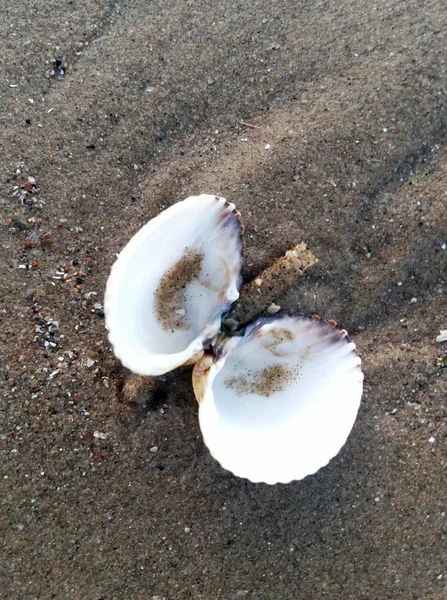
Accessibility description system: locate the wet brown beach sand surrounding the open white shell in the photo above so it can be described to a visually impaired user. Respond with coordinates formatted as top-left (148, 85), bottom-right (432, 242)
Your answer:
top-left (0, 0), bottom-right (447, 600)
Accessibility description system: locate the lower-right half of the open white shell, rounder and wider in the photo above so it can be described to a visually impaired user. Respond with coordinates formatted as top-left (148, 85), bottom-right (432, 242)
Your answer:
top-left (198, 316), bottom-right (363, 484)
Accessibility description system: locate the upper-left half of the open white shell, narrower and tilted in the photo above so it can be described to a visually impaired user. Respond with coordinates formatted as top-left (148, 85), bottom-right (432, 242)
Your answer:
top-left (104, 194), bottom-right (242, 375)
